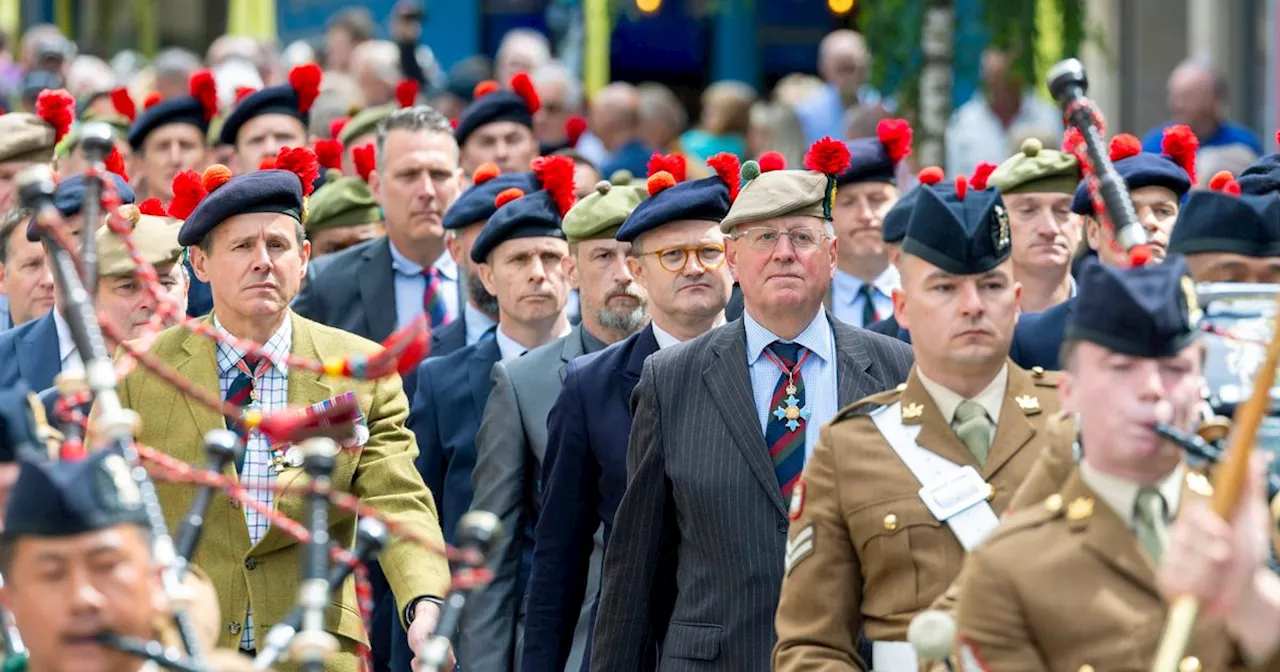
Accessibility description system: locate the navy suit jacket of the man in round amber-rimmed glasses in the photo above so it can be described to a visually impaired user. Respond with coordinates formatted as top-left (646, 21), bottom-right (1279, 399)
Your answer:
top-left (521, 326), bottom-right (658, 672)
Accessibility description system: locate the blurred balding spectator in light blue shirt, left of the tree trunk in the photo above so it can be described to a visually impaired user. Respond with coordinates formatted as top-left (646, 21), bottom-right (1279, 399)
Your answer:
top-left (796, 29), bottom-right (881, 143)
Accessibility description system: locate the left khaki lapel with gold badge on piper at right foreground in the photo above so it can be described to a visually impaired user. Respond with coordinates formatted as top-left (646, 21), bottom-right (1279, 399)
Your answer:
top-left (1062, 468), bottom-right (1160, 596)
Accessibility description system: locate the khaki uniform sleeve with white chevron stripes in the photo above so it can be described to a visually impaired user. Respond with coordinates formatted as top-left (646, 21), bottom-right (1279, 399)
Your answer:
top-left (773, 424), bottom-right (867, 672)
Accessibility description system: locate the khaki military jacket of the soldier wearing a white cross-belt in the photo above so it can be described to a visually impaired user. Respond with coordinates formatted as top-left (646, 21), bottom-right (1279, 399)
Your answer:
top-left (773, 362), bottom-right (1070, 671)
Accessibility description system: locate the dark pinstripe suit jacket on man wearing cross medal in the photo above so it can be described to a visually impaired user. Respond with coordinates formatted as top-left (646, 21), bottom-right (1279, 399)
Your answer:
top-left (591, 314), bottom-right (913, 672)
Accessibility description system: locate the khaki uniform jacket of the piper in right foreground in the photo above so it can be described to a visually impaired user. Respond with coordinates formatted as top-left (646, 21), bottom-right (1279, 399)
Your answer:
top-left (956, 467), bottom-right (1239, 672)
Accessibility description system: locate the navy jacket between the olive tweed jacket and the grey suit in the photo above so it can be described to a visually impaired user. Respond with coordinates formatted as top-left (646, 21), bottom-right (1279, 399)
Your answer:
top-left (408, 338), bottom-right (502, 544)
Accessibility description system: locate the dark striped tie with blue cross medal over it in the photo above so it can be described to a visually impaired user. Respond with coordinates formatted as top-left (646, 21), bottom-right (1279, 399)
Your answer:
top-left (763, 340), bottom-right (809, 500)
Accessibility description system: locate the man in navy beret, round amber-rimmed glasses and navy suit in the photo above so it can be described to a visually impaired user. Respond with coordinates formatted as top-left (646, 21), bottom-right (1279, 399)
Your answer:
top-left (521, 156), bottom-right (739, 672)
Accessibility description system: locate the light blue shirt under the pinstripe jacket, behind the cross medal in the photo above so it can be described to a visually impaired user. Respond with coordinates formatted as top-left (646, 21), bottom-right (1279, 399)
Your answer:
top-left (742, 311), bottom-right (840, 462)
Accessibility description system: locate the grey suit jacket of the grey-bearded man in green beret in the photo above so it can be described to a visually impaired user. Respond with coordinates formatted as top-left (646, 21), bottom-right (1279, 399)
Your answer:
top-left (468, 325), bottom-right (593, 672)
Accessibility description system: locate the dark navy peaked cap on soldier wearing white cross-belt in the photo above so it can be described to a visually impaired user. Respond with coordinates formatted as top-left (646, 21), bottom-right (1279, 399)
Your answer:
top-left (902, 183), bottom-right (1011, 275)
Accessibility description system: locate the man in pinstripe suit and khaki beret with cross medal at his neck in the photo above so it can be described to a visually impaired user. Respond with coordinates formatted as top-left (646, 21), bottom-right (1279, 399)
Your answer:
top-left (591, 138), bottom-right (911, 672)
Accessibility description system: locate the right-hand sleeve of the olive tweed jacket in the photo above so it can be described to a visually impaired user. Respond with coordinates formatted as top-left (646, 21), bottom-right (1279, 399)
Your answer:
top-left (352, 366), bottom-right (451, 618)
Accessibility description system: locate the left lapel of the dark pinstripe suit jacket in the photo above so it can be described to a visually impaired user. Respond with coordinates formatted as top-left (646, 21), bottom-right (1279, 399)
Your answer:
top-left (703, 319), bottom-right (787, 516)
